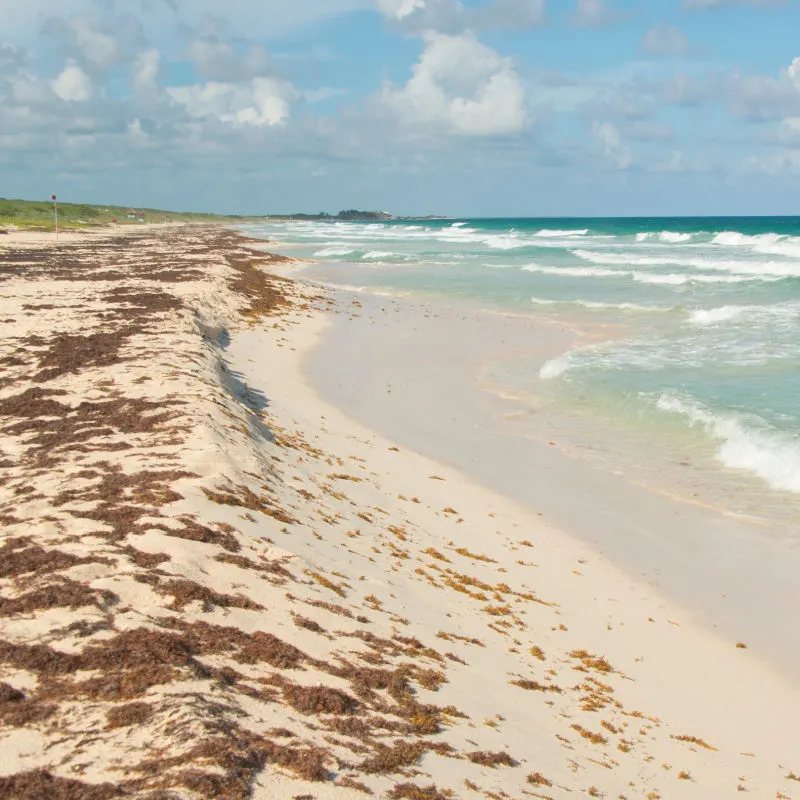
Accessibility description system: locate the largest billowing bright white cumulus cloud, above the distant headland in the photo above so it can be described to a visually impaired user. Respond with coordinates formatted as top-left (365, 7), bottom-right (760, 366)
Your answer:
top-left (377, 33), bottom-right (526, 136)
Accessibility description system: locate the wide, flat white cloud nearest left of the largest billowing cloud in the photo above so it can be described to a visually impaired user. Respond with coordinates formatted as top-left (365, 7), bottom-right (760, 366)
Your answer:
top-left (167, 78), bottom-right (297, 127)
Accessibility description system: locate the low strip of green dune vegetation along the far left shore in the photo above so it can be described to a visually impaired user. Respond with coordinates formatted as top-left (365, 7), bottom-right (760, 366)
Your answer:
top-left (0, 198), bottom-right (264, 230)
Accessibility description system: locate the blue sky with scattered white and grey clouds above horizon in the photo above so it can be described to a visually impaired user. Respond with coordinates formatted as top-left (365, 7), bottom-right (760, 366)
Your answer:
top-left (0, 0), bottom-right (800, 216)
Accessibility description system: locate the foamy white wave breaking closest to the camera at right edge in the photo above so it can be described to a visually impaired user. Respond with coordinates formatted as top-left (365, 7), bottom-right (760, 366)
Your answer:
top-left (652, 394), bottom-right (800, 492)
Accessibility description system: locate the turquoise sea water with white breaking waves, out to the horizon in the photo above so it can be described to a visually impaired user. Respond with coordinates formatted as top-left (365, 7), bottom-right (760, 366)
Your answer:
top-left (248, 217), bottom-right (800, 506)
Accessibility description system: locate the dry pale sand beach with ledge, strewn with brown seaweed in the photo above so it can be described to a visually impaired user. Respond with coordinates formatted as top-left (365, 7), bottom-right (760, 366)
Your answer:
top-left (0, 227), bottom-right (800, 800)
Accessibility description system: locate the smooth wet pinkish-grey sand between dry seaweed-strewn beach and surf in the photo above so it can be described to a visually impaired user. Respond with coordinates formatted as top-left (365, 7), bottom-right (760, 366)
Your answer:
top-left (308, 276), bottom-right (800, 675)
